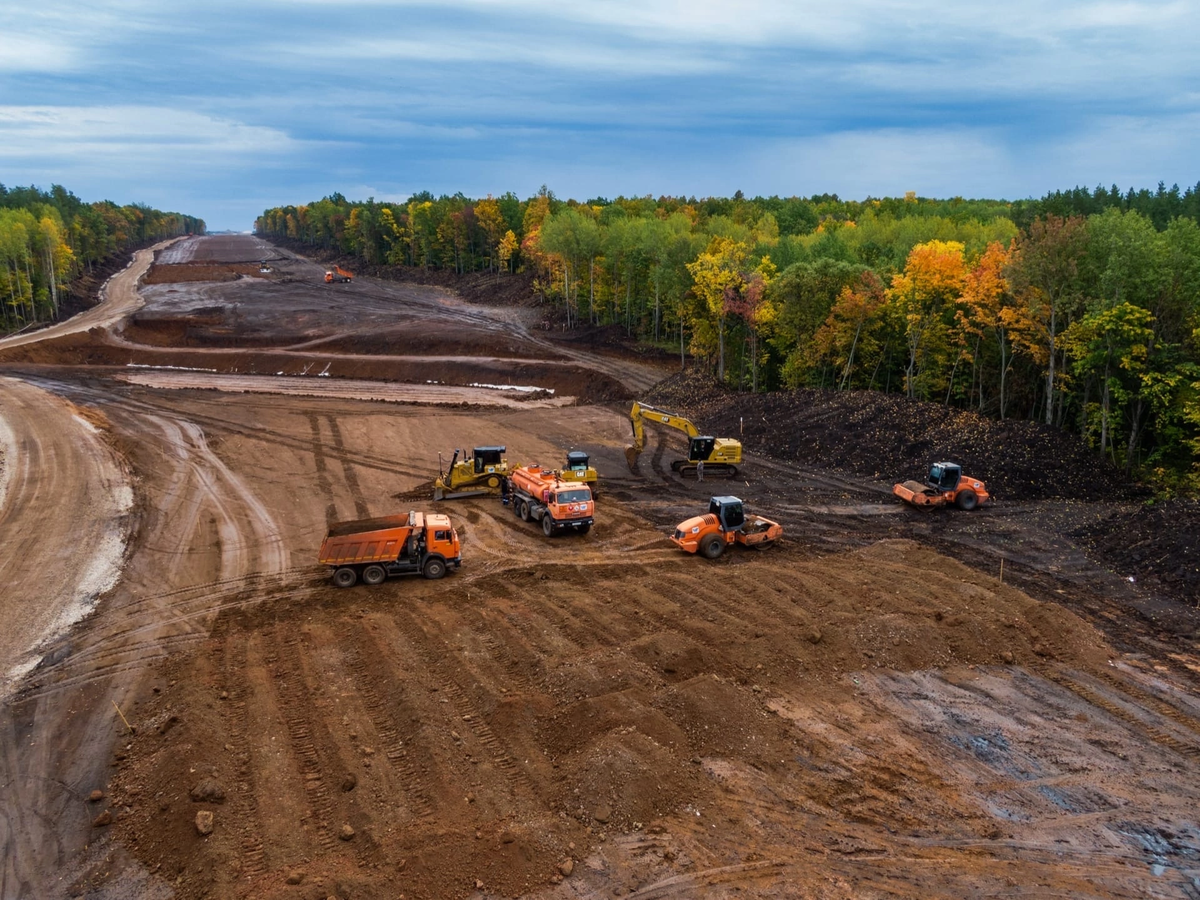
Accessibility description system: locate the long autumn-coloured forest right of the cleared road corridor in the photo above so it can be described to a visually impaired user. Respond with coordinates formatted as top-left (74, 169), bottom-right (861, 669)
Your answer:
top-left (257, 184), bottom-right (1200, 488)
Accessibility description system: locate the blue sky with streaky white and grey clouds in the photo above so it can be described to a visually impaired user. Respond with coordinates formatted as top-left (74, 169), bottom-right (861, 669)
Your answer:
top-left (0, 0), bottom-right (1200, 229)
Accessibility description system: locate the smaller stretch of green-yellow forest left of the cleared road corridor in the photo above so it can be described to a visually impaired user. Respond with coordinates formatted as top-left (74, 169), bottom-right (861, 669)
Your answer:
top-left (0, 184), bottom-right (204, 334)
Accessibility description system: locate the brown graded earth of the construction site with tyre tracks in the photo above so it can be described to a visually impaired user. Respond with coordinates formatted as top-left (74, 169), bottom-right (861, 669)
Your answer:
top-left (0, 235), bottom-right (1200, 900)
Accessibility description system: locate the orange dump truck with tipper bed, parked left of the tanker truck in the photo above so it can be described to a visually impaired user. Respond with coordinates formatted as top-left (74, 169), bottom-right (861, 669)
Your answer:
top-left (318, 510), bottom-right (462, 588)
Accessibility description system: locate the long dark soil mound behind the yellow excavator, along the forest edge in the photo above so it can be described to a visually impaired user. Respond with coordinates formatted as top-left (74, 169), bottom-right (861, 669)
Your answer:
top-left (647, 371), bottom-right (1138, 500)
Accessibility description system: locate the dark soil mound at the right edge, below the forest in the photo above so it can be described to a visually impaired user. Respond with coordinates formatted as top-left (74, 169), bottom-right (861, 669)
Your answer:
top-left (1074, 500), bottom-right (1200, 606)
